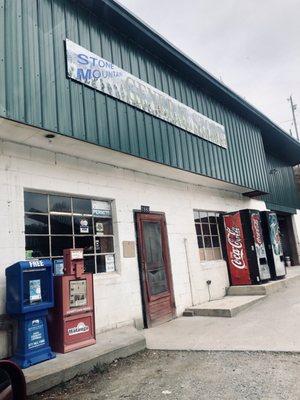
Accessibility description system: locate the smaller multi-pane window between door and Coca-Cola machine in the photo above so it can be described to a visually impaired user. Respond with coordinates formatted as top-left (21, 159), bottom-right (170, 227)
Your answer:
top-left (194, 210), bottom-right (223, 261)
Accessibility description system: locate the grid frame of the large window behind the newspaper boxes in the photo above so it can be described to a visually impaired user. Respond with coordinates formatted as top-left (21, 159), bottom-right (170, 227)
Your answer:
top-left (23, 189), bottom-right (117, 275)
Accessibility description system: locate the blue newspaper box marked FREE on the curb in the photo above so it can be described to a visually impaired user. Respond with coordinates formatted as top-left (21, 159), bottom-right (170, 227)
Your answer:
top-left (5, 260), bottom-right (55, 368)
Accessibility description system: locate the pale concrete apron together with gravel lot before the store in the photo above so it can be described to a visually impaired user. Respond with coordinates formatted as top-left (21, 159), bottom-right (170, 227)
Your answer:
top-left (29, 270), bottom-right (300, 400)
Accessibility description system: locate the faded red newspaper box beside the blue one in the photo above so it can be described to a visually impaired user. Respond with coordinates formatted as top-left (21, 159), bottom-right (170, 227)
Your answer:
top-left (48, 249), bottom-right (96, 353)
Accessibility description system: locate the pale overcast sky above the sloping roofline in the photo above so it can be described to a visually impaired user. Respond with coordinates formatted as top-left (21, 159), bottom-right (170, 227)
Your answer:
top-left (118, 0), bottom-right (300, 137)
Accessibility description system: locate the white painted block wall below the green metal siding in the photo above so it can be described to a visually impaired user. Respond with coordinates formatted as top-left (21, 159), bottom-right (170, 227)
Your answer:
top-left (0, 137), bottom-right (268, 353)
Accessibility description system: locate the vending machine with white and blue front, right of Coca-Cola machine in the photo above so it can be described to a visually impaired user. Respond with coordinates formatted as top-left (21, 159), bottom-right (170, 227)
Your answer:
top-left (260, 211), bottom-right (286, 279)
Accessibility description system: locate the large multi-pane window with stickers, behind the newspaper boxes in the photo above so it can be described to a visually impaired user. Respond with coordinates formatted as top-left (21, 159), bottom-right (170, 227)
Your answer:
top-left (24, 191), bottom-right (115, 273)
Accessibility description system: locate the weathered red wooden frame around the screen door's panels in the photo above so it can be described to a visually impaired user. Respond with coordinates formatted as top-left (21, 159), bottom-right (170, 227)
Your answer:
top-left (133, 210), bottom-right (176, 328)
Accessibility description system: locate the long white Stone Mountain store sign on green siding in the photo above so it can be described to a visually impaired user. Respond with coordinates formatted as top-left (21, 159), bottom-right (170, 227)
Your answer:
top-left (66, 39), bottom-right (227, 148)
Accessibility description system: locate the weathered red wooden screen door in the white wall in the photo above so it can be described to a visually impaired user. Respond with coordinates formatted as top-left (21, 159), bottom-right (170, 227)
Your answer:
top-left (136, 213), bottom-right (175, 327)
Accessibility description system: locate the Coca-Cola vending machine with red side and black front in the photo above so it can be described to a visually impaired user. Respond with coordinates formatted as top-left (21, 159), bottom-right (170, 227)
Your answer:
top-left (222, 210), bottom-right (271, 286)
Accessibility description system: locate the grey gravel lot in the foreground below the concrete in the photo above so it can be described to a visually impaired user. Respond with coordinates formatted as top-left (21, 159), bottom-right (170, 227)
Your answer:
top-left (30, 350), bottom-right (300, 400)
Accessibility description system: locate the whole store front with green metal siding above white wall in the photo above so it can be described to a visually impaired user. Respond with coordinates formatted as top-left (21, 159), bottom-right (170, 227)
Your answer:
top-left (0, 0), bottom-right (300, 355)
